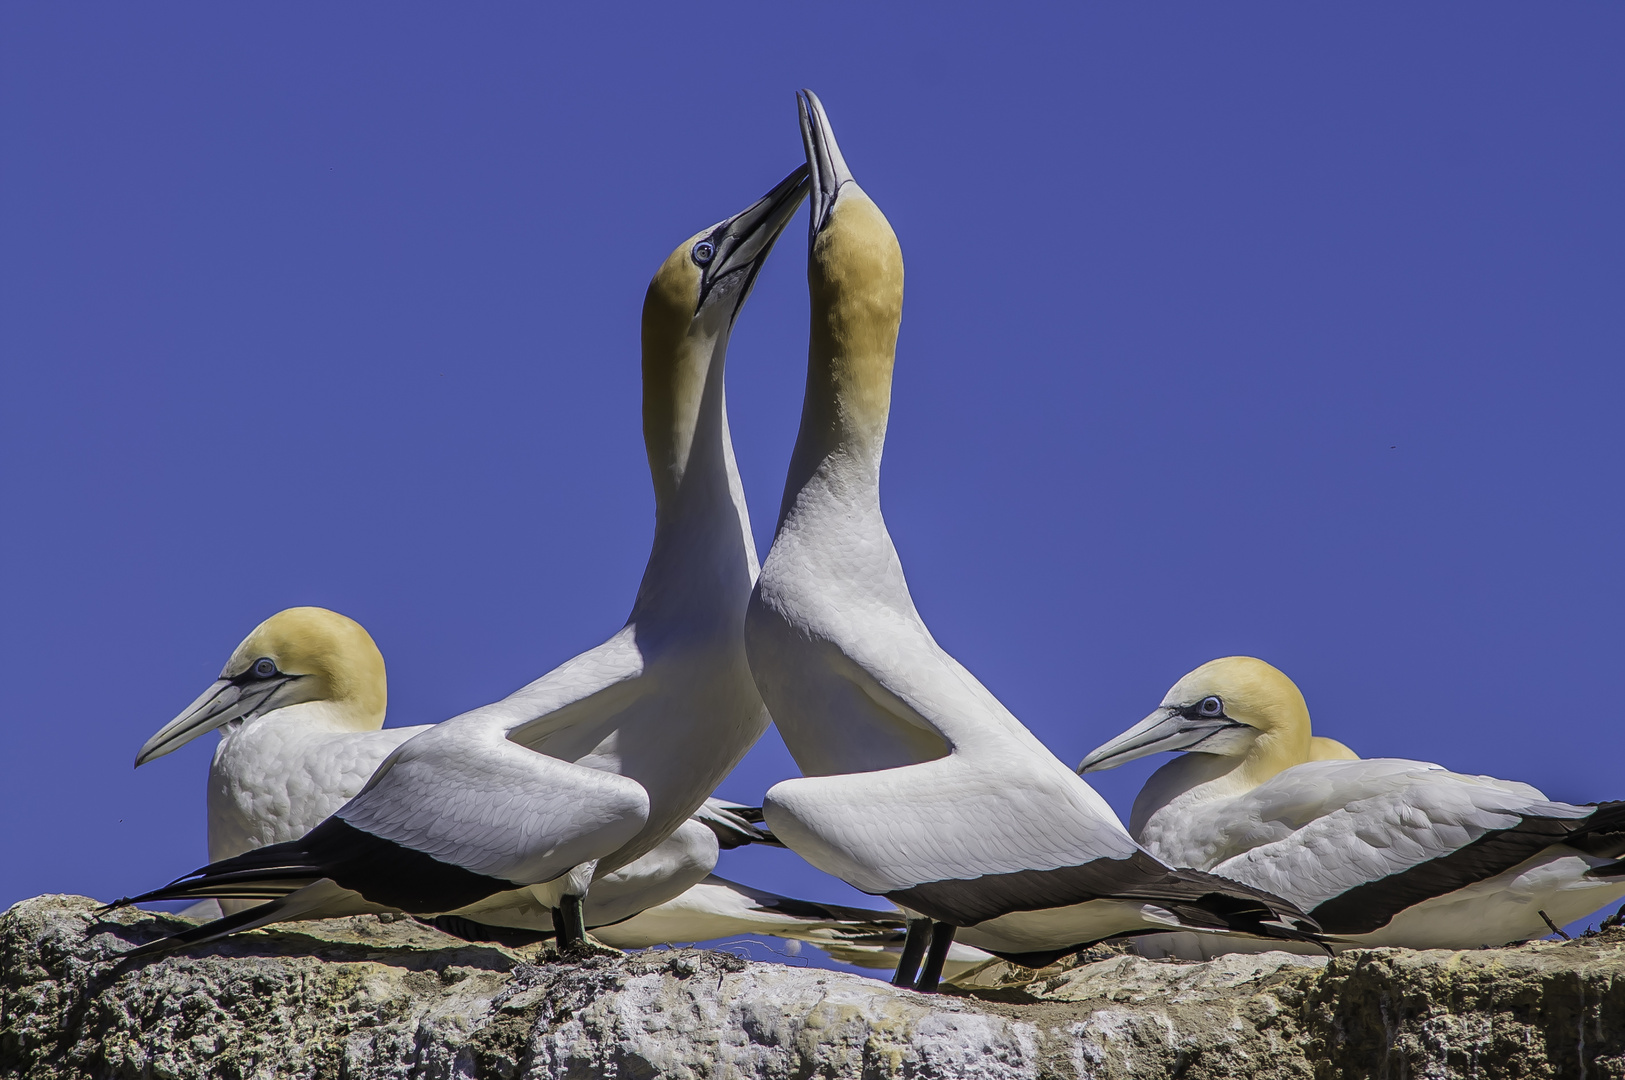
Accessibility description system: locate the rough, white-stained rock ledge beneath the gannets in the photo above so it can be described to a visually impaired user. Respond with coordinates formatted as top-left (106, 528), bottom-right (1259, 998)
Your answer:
top-left (0, 896), bottom-right (1625, 1080)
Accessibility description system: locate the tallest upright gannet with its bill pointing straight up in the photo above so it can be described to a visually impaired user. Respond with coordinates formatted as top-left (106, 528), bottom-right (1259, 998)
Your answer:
top-left (746, 91), bottom-right (1308, 991)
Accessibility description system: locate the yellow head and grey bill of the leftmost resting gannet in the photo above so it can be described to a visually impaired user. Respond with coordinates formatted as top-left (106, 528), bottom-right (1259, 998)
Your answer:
top-left (135, 607), bottom-right (388, 765)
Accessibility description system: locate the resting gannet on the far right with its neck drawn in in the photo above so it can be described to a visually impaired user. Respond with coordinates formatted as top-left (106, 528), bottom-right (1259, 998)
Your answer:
top-left (1079, 656), bottom-right (1625, 958)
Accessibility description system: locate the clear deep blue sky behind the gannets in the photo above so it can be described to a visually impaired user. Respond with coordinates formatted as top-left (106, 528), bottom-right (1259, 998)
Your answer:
top-left (0, 3), bottom-right (1625, 961)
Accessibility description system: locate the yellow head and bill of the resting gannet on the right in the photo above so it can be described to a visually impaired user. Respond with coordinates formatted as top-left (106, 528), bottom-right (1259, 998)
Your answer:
top-left (1077, 656), bottom-right (1354, 783)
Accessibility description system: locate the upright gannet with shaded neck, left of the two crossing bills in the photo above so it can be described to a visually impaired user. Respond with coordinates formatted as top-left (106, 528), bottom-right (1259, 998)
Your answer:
top-left (120, 166), bottom-right (808, 952)
